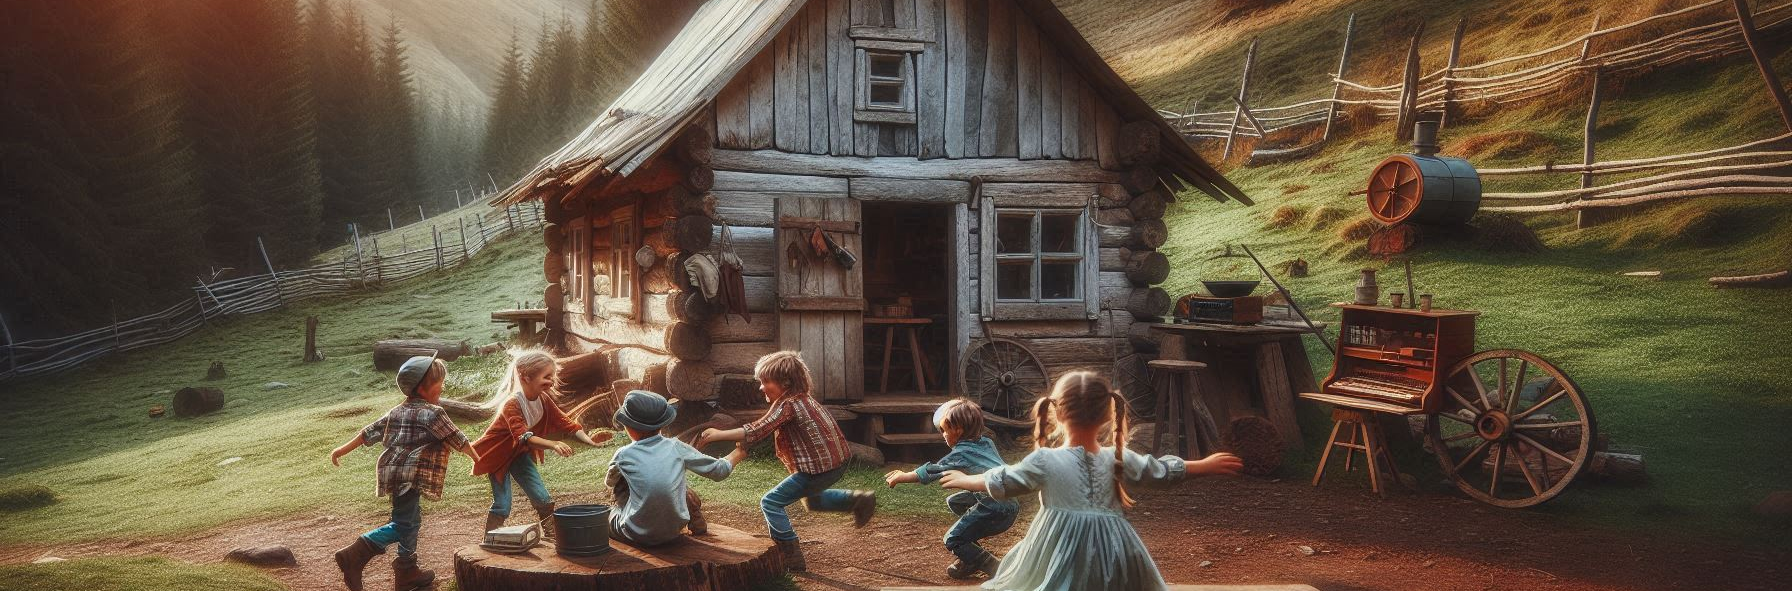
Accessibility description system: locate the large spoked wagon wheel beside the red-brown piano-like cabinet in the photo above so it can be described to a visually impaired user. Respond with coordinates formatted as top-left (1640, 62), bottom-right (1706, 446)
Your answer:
top-left (1425, 349), bottom-right (1595, 509)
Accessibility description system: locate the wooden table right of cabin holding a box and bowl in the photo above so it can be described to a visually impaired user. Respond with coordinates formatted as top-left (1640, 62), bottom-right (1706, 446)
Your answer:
top-left (1150, 322), bottom-right (1324, 450)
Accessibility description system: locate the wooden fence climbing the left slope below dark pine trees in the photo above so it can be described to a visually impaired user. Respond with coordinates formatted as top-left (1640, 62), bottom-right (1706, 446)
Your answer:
top-left (0, 202), bottom-right (543, 380)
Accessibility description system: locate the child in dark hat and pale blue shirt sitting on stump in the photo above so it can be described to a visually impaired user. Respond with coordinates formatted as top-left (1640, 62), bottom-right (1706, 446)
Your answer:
top-left (604, 390), bottom-right (747, 546)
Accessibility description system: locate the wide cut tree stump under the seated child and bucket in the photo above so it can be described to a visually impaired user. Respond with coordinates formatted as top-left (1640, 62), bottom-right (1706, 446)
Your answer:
top-left (453, 523), bottom-right (783, 591)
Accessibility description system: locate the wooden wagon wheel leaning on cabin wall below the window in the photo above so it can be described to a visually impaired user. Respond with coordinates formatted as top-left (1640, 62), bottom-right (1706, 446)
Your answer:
top-left (959, 338), bottom-right (1047, 421)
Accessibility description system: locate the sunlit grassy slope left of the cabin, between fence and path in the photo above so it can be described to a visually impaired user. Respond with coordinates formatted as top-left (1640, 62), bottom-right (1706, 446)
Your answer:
top-left (0, 238), bottom-right (939, 544)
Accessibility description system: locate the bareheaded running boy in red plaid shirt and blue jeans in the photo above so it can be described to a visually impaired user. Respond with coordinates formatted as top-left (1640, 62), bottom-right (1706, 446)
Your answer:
top-left (697, 351), bottom-right (878, 571)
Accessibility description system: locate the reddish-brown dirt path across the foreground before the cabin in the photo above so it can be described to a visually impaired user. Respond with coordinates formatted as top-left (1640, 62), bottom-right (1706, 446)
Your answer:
top-left (0, 480), bottom-right (1792, 591)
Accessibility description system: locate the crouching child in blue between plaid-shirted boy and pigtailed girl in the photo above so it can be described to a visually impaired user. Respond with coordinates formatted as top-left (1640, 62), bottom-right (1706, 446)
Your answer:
top-left (883, 398), bottom-right (1020, 578)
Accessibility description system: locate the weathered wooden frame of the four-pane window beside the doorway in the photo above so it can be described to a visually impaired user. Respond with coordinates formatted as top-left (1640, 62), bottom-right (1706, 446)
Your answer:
top-left (978, 202), bottom-right (1100, 321)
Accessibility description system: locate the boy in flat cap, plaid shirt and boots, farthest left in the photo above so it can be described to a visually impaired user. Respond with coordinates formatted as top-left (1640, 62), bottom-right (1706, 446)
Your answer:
top-left (330, 356), bottom-right (478, 591)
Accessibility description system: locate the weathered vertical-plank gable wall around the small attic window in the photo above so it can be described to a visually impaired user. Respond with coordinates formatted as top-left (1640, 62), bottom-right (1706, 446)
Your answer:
top-left (715, 0), bottom-right (1118, 161)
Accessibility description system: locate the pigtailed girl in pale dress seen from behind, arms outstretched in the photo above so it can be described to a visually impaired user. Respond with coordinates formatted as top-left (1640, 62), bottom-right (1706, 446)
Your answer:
top-left (941, 371), bottom-right (1244, 591)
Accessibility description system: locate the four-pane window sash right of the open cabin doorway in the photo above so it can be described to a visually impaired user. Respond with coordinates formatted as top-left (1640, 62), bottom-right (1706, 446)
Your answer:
top-left (993, 210), bottom-right (1084, 303)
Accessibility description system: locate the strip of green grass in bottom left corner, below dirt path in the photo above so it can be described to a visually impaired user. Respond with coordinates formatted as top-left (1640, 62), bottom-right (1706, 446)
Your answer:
top-left (0, 559), bottom-right (285, 591)
